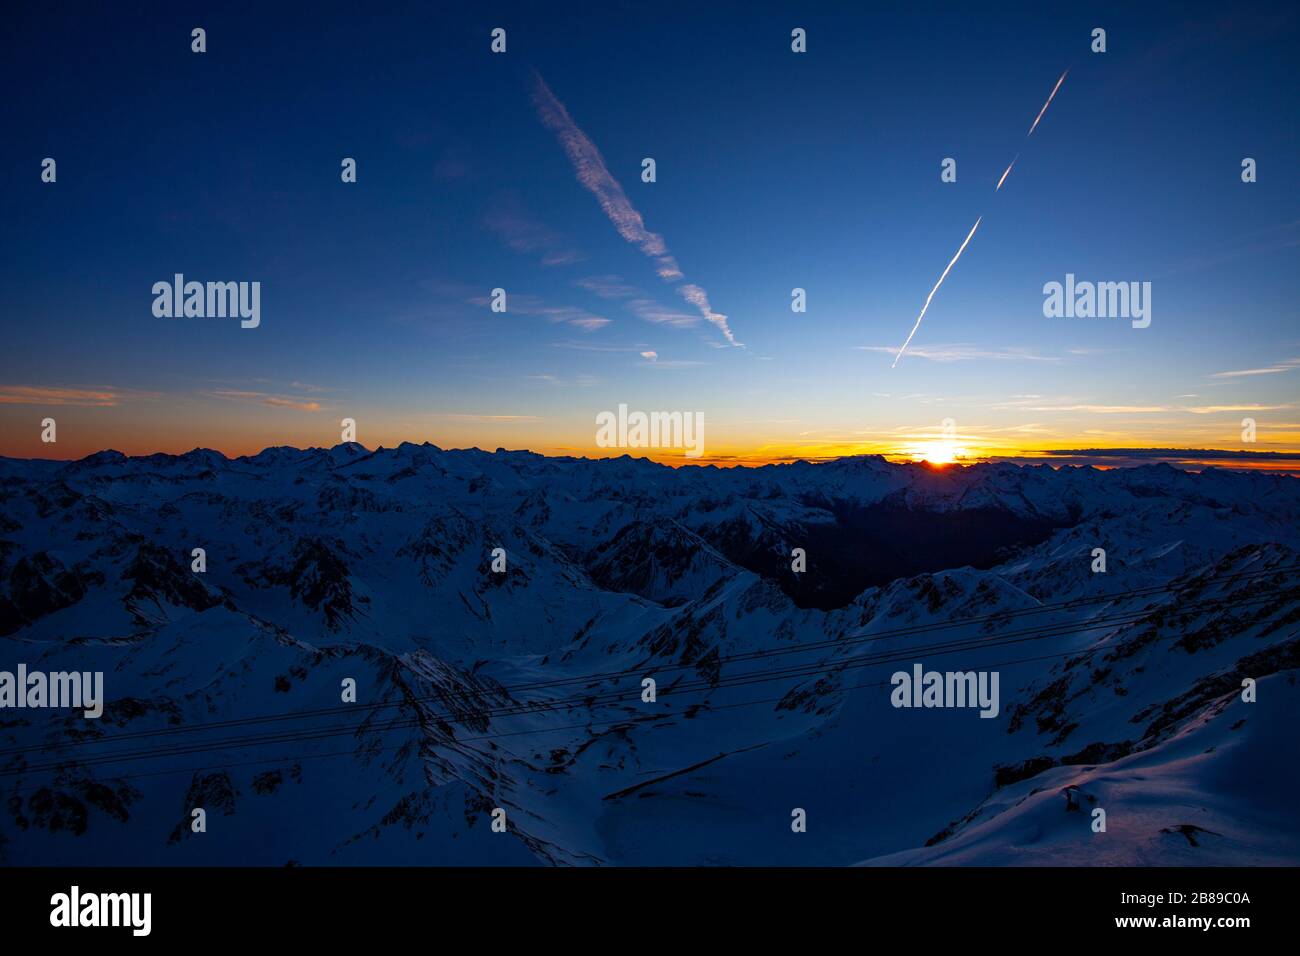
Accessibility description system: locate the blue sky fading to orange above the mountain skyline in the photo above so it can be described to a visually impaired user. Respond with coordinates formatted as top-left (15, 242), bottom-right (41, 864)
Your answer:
top-left (0, 3), bottom-right (1300, 464)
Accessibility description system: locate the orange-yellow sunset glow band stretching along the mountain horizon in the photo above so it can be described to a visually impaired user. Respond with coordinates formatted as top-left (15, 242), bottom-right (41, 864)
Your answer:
top-left (0, 403), bottom-right (1300, 473)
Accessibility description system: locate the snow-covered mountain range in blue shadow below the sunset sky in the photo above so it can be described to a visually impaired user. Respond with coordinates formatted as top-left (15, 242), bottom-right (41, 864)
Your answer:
top-left (0, 444), bottom-right (1300, 865)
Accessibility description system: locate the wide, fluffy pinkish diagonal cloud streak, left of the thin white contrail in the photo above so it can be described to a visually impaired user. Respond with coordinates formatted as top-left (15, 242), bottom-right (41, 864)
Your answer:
top-left (533, 74), bottom-right (740, 346)
